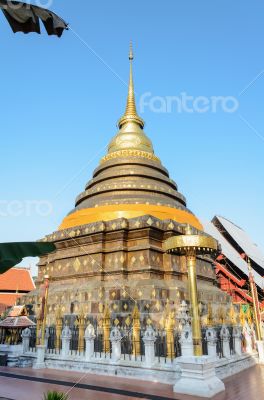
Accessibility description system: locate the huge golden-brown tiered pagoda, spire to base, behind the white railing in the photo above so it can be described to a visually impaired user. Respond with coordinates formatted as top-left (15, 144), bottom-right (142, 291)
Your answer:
top-left (23, 46), bottom-right (231, 323)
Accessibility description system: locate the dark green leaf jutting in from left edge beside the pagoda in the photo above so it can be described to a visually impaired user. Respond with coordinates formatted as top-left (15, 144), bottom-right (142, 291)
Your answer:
top-left (0, 242), bottom-right (56, 274)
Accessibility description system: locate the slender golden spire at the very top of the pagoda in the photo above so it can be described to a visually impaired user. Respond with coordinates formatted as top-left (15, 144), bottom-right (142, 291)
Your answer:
top-left (118, 42), bottom-right (144, 128)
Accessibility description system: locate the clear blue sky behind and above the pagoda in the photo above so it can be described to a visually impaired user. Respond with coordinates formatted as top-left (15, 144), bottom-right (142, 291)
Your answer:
top-left (0, 0), bottom-right (264, 274)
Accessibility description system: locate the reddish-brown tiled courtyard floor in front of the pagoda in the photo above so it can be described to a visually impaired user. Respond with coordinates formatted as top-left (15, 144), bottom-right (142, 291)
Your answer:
top-left (0, 365), bottom-right (264, 400)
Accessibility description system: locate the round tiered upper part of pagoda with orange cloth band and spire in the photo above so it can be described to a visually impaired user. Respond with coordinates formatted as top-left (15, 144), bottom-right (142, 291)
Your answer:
top-left (59, 46), bottom-right (202, 229)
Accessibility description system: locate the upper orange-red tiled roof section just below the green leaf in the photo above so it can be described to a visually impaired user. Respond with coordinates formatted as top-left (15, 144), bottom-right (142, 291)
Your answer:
top-left (0, 268), bottom-right (35, 292)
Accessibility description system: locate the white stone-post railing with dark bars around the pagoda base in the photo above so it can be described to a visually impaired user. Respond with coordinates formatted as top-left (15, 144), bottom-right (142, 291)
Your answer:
top-left (22, 323), bottom-right (253, 365)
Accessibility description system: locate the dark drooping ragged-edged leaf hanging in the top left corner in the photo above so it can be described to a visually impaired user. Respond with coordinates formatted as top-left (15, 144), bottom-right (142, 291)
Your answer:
top-left (0, 0), bottom-right (68, 37)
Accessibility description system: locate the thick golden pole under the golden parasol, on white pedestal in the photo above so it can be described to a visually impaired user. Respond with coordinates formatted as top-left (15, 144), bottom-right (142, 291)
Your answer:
top-left (186, 252), bottom-right (203, 356)
